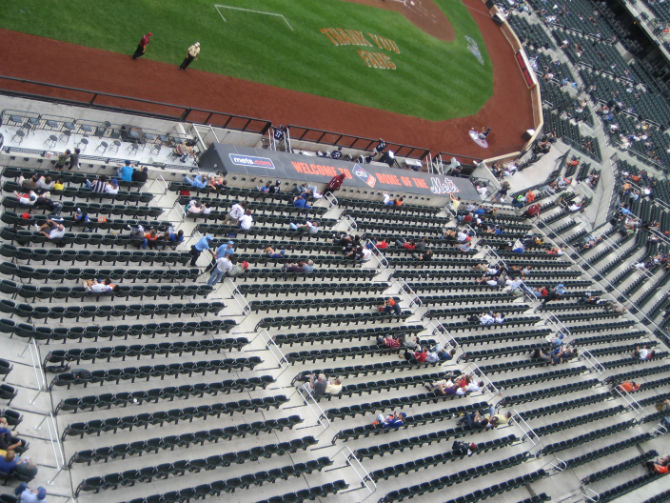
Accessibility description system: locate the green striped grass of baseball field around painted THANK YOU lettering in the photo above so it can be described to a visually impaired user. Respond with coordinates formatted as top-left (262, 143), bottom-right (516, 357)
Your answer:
top-left (0, 0), bottom-right (493, 121)
